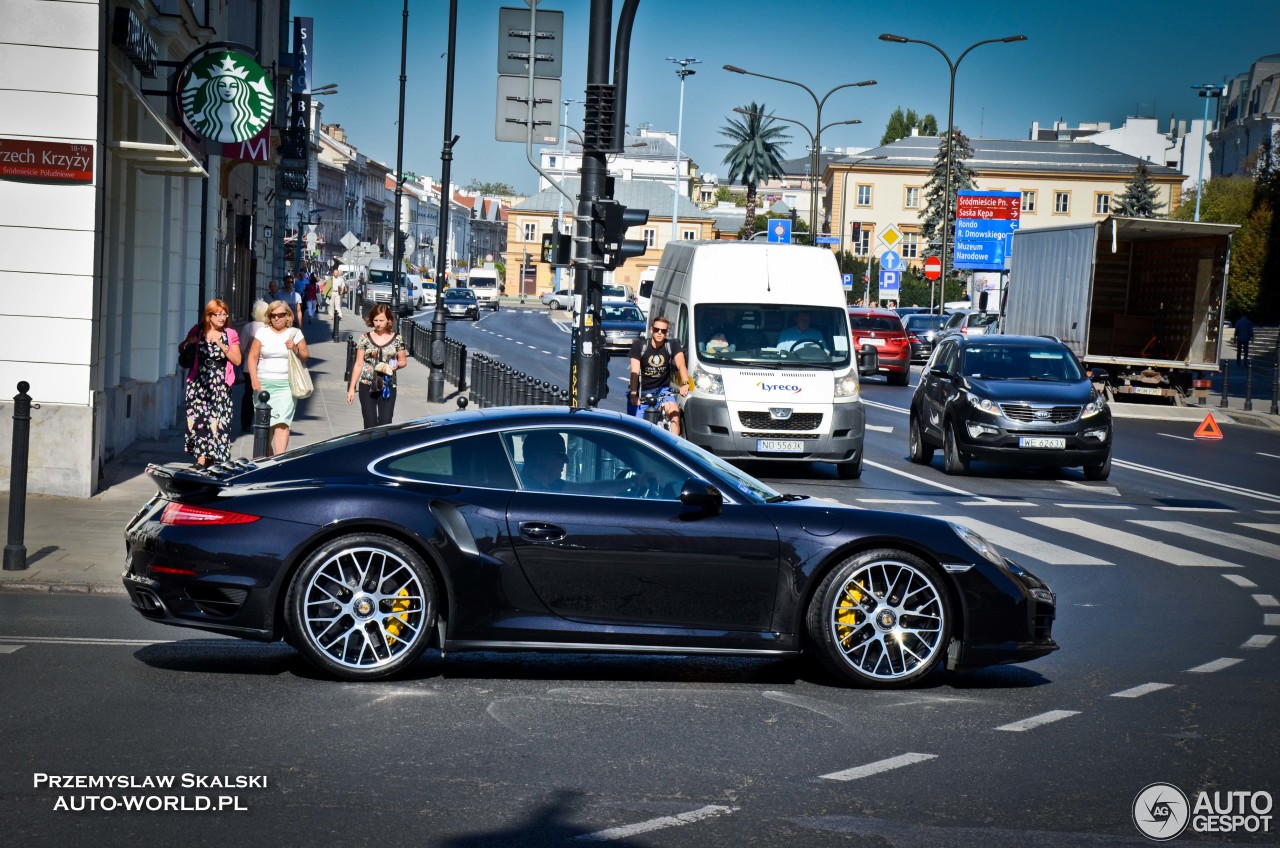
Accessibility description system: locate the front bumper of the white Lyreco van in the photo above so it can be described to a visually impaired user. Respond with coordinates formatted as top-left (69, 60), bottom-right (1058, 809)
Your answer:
top-left (681, 395), bottom-right (867, 462)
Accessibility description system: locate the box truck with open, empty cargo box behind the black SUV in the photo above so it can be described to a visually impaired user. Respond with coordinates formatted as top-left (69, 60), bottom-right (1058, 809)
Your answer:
top-left (1000, 216), bottom-right (1236, 404)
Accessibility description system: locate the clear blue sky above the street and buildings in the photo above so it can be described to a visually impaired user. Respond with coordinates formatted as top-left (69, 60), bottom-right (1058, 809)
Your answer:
top-left (291, 0), bottom-right (1280, 192)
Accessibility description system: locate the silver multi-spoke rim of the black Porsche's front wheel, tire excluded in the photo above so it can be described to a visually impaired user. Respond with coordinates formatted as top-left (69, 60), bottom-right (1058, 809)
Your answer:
top-left (829, 559), bottom-right (948, 681)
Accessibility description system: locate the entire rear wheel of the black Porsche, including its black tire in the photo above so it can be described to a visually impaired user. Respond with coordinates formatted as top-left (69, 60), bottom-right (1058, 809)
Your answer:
top-left (285, 533), bottom-right (439, 680)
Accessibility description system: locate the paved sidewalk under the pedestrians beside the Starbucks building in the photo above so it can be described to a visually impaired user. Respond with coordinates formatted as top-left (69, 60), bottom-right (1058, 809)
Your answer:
top-left (0, 310), bottom-right (457, 594)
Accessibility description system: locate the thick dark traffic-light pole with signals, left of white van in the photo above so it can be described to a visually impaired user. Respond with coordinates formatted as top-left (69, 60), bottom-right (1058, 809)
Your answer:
top-left (570, 0), bottom-right (649, 409)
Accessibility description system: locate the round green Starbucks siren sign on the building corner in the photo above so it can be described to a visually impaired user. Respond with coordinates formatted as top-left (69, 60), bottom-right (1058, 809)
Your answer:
top-left (182, 50), bottom-right (275, 143)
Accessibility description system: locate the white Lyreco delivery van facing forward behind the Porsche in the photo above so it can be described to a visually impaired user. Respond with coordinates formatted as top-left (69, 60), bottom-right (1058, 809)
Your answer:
top-left (649, 241), bottom-right (865, 479)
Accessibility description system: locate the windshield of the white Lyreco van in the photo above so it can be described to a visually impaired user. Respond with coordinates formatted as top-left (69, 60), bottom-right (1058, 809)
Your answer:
top-left (694, 304), bottom-right (850, 368)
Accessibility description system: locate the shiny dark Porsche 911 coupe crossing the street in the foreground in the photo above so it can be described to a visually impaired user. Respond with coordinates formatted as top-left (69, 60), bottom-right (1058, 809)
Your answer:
top-left (124, 407), bottom-right (1057, 688)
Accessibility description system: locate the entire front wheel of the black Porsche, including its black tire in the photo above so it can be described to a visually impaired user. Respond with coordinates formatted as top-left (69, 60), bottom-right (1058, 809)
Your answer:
top-left (805, 548), bottom-right (951, 689)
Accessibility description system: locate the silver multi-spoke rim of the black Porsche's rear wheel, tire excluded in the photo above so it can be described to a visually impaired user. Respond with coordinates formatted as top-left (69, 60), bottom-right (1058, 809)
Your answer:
top-left (300, 547), bottom-right (431, 670)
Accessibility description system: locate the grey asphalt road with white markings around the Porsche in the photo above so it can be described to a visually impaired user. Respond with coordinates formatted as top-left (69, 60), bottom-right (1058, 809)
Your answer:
top-left (0, 310), bottom-right (1280, 848)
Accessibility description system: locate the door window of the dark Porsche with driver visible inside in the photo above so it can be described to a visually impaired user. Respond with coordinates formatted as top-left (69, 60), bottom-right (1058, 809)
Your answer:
top-left (503, 427), bottom-right (689, 501)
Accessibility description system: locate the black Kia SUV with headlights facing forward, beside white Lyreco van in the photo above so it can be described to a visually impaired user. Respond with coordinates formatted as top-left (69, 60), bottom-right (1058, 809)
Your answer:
top-left (908, 333), bottom-right (1111, 480)
